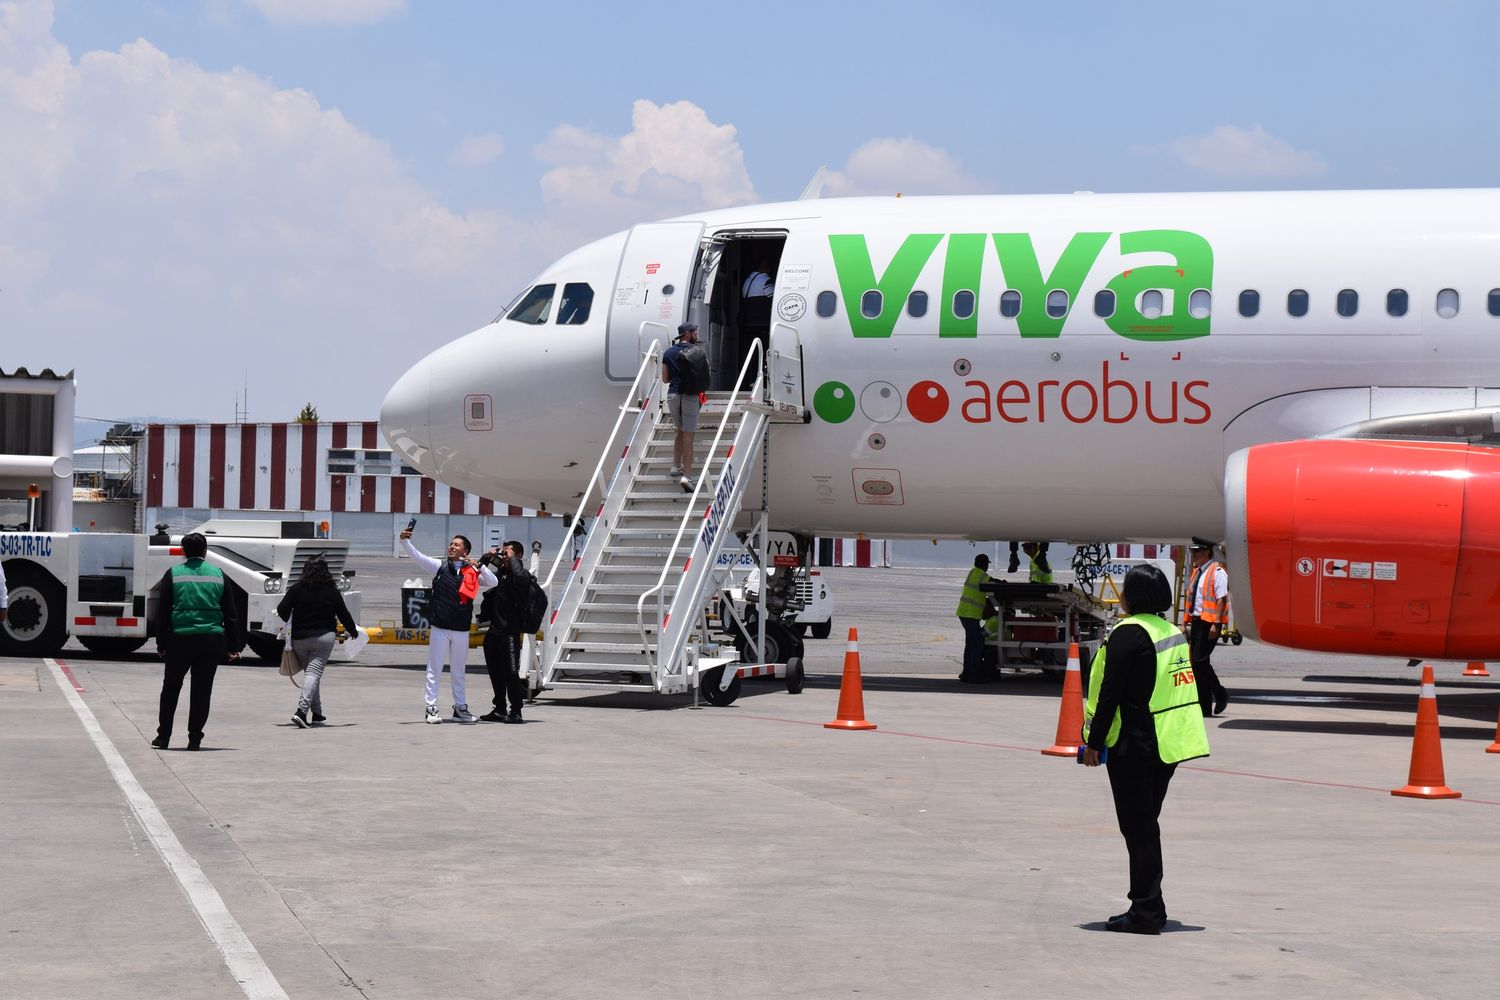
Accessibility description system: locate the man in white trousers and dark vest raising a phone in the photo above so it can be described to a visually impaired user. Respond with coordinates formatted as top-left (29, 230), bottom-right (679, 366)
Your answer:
top-left (401, 517), bottom-right (498, 726)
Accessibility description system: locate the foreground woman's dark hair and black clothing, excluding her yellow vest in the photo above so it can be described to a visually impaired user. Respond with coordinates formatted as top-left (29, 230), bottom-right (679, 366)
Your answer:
top-left (1083, 564), bottom-right (1178, 934)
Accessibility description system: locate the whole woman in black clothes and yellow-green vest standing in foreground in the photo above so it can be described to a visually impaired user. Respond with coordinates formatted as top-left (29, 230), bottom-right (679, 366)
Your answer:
top-left (1082, 564), bottom-right (1209, 934)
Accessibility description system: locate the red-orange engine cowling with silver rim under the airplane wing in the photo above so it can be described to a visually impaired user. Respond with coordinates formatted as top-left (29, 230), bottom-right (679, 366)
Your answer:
top-left (1226, 439), bottom-right (1500, 660)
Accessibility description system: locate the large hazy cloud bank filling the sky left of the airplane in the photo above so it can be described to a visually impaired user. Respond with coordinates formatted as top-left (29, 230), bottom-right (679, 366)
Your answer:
top-left (0, 0), bottom-right (510, 420)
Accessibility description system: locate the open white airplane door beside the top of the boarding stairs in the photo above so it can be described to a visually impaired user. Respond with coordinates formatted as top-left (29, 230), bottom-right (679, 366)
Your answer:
top-left (605, 222), bottom-right (704, 379)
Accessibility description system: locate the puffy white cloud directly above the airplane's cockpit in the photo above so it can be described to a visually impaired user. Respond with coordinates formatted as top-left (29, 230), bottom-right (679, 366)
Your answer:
top-left (537, 100), bottom-right (756, 228)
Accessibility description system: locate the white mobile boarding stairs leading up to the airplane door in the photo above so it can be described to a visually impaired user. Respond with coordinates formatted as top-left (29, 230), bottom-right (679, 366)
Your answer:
top-left (540, 345), bottom-right (800, 694)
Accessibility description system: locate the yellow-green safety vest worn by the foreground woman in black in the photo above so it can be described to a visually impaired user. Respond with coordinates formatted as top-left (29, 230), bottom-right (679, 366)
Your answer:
top-left (1083, 615), bottom-right (1209, 765)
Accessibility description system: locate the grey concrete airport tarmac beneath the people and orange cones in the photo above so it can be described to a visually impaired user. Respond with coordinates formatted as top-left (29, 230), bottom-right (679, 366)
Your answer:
top-left (0, 561), bottom-right (1500, 1000)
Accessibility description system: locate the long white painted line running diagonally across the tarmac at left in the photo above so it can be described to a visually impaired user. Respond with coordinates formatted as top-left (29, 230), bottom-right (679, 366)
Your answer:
top-left (44, 660), bottom-right (288, 1000)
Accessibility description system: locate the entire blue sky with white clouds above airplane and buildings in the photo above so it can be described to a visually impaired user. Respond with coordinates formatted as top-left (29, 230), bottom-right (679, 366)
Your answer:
top-left (0, 0), bottom-right (1500, 431)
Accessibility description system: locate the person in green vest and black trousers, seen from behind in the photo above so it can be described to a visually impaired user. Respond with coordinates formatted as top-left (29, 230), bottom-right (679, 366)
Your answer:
top-left (152, 531), bottom-right (245, 750)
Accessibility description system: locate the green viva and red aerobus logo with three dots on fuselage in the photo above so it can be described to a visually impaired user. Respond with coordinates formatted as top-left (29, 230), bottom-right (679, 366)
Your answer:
top-left (813, 229), bottom-right (1214, 424)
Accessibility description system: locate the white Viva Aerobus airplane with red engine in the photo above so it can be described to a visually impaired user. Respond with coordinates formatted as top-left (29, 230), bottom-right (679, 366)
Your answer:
top-left (381, 190), bottom-right (1500, 660)
